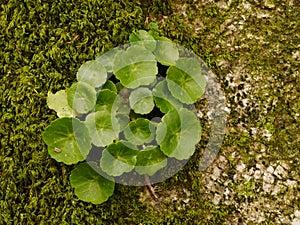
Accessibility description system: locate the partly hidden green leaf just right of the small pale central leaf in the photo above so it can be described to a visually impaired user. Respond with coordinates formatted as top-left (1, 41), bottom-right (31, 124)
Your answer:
top-left (152, 80), bottom-right (182, 113)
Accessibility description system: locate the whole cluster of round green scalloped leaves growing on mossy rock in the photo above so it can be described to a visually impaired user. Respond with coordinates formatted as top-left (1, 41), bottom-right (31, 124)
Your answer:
top-left (43, 30), bottom-right (206, 204)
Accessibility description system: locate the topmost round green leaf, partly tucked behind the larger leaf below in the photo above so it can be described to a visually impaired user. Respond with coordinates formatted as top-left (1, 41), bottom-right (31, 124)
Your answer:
top-left (129, 30), bottom-right (156, 52)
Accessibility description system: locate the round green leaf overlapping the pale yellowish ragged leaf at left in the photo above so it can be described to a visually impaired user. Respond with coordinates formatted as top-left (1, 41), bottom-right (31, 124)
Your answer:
top-left (67, 82), bottom-right (96, 114)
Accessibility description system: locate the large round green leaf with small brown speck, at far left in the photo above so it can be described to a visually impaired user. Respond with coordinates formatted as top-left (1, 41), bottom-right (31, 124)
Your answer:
top-left (43, 118), bottom-right (92, 165)
